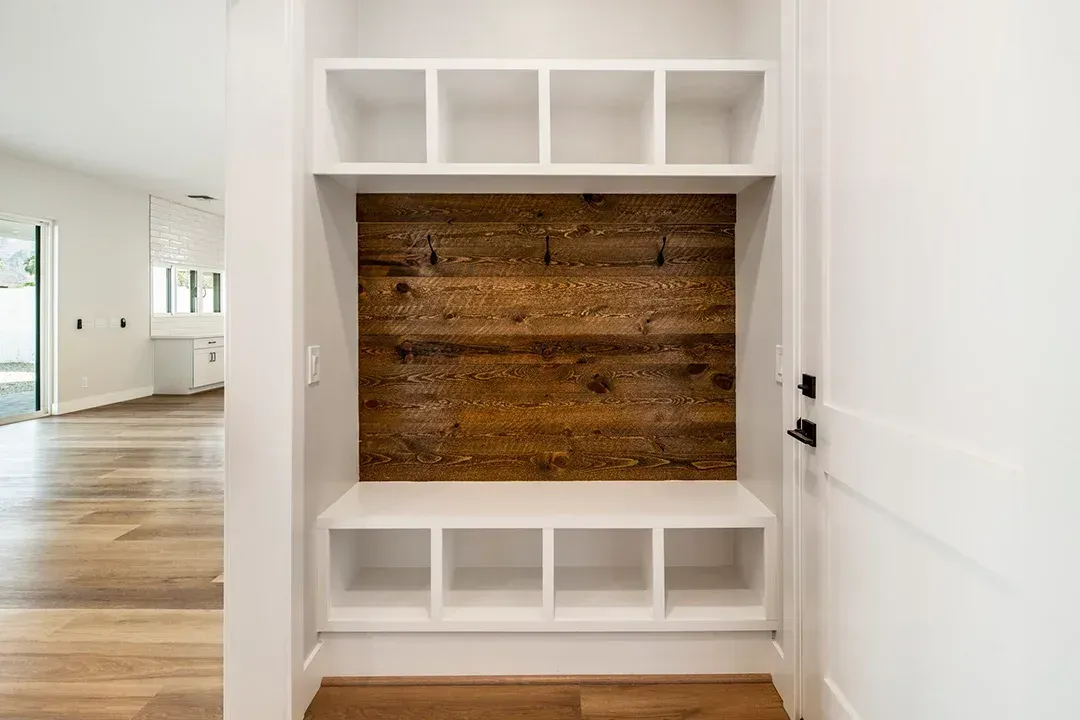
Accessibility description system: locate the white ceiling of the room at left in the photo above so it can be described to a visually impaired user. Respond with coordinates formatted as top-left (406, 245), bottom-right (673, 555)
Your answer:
top-left (0, 0), bottom-right (226, 213)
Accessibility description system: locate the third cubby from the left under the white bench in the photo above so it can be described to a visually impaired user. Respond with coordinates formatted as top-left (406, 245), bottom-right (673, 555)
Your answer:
top-left (555, 529), bottom-right (653, 621)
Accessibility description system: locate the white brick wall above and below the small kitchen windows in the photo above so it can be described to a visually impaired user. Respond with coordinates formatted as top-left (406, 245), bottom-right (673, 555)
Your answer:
top-left (150, 195), bottom-right (225, 336)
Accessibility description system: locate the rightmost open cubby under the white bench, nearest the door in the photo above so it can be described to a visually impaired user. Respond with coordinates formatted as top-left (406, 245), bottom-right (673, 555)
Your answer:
top-left (664, 528), bottom-right (766, 621)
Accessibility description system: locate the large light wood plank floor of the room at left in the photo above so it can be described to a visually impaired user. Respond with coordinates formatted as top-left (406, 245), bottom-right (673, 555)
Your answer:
top-left (0, 392), bottom-right (224, 720)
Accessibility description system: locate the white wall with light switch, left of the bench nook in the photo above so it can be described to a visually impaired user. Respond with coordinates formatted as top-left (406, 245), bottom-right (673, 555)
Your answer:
top-left (225, 0), bottom-right (357, 720)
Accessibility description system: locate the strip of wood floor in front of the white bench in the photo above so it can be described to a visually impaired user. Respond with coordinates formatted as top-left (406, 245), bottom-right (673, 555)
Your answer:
top-left (307, 682), bottom-right (787, 720)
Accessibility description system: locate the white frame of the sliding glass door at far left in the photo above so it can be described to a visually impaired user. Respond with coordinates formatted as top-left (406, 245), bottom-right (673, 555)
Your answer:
top-left (0, 210), bottom-right (57, 425)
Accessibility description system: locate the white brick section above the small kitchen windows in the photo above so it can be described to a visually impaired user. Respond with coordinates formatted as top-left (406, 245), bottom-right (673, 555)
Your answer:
top-left (150, 195), bottom-right (225, 269)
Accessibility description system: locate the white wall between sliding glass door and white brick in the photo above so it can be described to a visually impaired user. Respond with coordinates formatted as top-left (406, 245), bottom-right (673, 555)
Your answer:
top-left (0, 148), bottom-right (153, 412)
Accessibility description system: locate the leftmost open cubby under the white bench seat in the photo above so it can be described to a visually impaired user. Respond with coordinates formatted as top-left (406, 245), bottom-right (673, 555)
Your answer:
top-left (327, 530), bottom-right (431, 622)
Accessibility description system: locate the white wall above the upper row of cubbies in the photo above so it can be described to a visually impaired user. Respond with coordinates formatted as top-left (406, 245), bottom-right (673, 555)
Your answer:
top-left (355, 0), bottom-right (780, 59)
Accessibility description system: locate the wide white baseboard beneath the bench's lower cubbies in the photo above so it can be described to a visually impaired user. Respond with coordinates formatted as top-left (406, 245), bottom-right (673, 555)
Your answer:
top-left (319, 633), bottom-right (777, 677)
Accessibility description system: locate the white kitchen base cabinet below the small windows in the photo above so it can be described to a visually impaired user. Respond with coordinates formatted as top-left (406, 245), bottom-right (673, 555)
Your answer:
top-left (153, 336), bottom-right (225, 395)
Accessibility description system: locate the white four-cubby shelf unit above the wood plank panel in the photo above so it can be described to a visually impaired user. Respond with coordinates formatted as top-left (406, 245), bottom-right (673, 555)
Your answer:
top-left (312, 58), bottom-right (779, 191)
